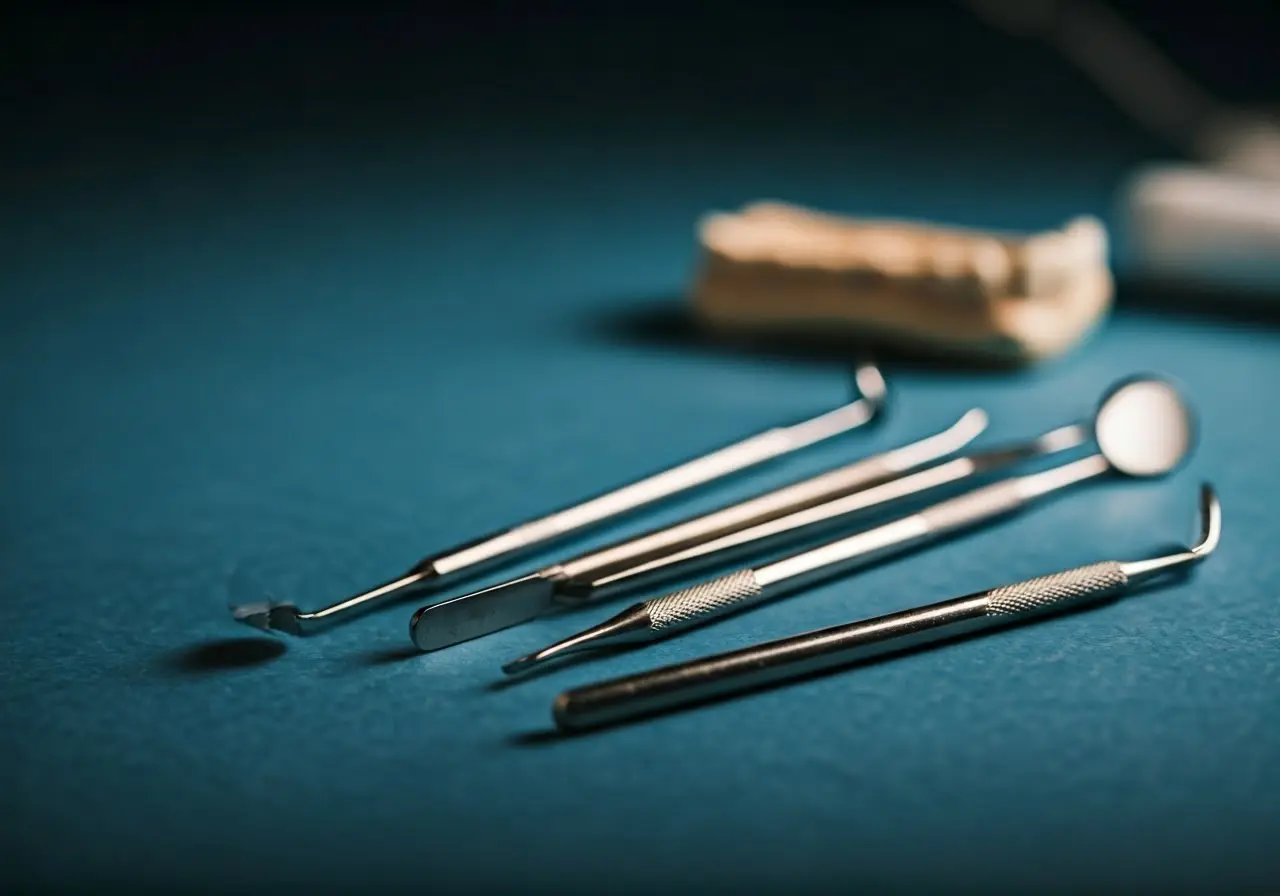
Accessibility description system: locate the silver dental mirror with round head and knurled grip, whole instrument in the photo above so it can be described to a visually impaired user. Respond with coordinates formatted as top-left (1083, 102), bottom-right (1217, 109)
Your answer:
top-left (503, 378), bottom-right (1194, 675)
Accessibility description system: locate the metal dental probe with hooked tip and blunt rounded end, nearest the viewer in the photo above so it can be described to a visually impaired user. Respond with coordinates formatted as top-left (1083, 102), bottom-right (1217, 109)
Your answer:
top-left (552, 484), bottom-right (1222, 731)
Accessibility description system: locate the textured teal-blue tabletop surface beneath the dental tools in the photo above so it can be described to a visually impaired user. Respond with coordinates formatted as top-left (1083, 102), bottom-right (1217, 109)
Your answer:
top-left (0, 5), bottom-right (1280, 892)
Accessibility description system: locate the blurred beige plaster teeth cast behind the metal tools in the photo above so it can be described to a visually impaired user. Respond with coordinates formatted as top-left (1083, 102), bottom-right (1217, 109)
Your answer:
top-left (690, 202), bottom-right (1112, 362)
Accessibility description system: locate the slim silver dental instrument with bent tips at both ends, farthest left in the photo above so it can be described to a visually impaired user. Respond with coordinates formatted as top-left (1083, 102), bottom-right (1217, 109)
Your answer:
top-left (232, 364), bottom-right (887, 635)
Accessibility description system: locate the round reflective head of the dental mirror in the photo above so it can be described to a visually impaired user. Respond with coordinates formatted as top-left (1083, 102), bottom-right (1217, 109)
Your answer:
top-left (1093, 379), bottom-right (1196, 476)
